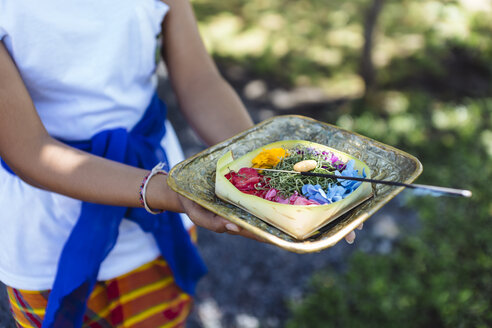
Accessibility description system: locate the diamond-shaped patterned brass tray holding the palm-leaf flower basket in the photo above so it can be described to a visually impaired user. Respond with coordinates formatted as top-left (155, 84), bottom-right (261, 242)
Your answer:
top-left (168, 115), bottom-right (422, 253)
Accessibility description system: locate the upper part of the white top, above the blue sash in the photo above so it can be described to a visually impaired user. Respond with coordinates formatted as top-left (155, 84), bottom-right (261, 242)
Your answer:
top-left (0, 0), bottom-right (168, 140)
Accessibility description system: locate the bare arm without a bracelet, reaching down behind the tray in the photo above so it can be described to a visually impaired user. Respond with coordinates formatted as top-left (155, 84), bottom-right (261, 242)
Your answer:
top-left (162, 0), bottom-right (253, 144)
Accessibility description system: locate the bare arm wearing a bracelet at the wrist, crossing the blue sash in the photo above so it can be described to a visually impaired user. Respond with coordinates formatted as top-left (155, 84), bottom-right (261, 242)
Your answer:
top-left (0, 42), bottom-right (182, 211)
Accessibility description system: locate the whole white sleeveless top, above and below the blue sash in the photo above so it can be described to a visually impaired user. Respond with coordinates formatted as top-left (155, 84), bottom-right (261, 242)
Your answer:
top-left (0, 0), bottom-right (194, 290)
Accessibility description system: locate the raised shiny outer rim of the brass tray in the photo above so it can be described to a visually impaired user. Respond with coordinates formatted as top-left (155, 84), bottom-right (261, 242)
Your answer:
top-left (167, 115), bottom-right (423, 254)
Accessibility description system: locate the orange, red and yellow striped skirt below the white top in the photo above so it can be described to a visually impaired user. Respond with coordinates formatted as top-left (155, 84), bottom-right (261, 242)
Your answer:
top-left (7, 242), bottom-right (196, 328)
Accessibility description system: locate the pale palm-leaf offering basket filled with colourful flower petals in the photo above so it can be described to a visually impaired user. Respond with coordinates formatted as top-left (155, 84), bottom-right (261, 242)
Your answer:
top-left (215, 140), bottom-right (372, 240)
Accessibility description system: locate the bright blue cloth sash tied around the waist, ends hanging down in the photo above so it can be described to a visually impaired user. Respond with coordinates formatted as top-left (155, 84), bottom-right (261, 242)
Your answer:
top-left (2, 96), bottom-right (207, 328)
